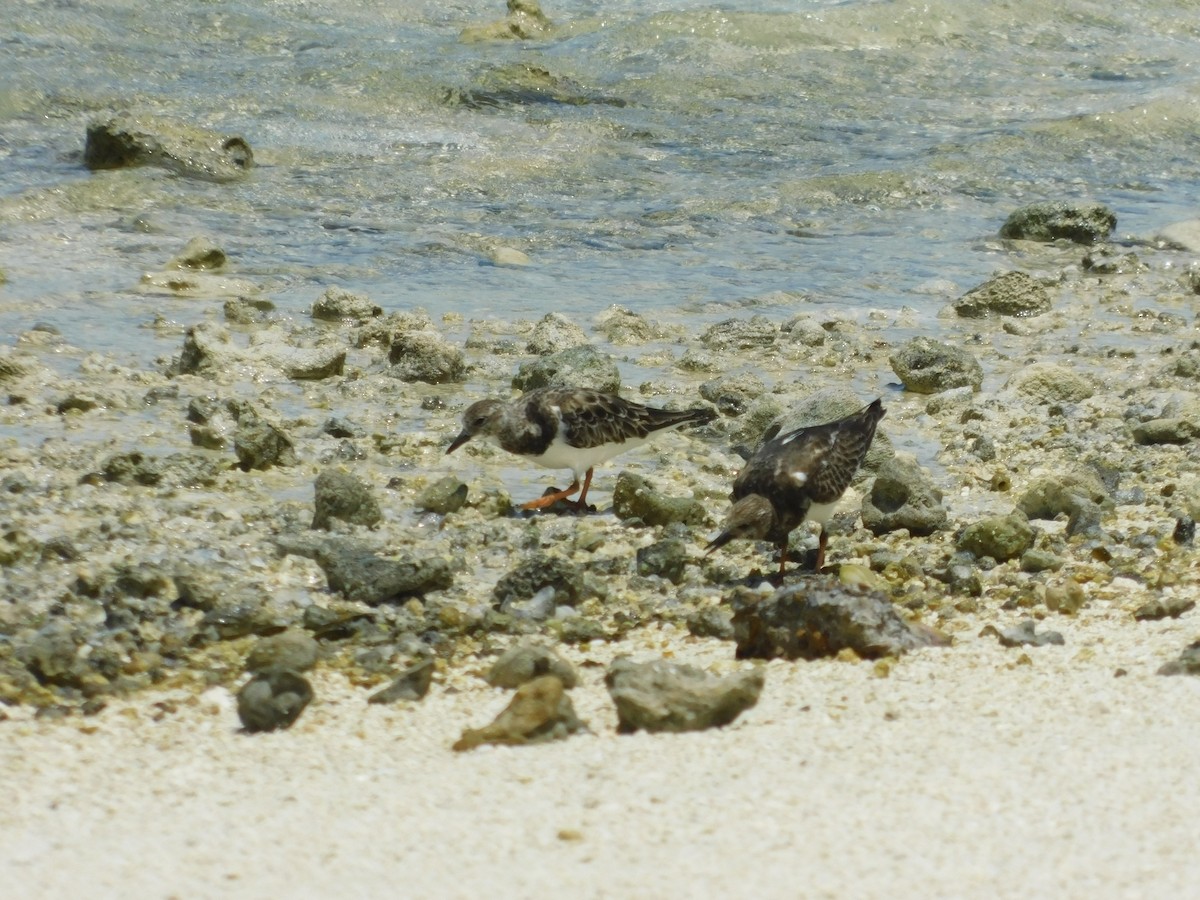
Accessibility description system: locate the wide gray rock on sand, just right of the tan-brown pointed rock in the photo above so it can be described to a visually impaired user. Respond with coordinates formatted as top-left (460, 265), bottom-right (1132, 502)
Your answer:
top-left (605, 656), bottom-right (766, 734)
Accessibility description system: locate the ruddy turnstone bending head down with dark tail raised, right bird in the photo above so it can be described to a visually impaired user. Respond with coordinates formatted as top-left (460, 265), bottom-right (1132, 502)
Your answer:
top-left (706, 400), bottom-right (884, 575)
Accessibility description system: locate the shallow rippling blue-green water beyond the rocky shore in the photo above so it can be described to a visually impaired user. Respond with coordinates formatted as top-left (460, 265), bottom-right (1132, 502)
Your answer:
top-left (0, 0), bottom-right (1200, 360)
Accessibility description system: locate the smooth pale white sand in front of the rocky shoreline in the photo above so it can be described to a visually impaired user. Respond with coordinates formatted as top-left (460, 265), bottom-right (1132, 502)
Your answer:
top-left (0, 605), bottom-right (1200, 898)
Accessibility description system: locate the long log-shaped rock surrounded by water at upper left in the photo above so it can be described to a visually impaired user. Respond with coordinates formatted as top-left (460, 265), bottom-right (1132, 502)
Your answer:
top-left (83, 114), bottom-right (254, 181)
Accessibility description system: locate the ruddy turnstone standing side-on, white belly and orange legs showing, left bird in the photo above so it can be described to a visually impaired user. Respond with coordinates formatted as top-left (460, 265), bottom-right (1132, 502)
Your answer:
top-left (446, 388), bottom-right (716, 510)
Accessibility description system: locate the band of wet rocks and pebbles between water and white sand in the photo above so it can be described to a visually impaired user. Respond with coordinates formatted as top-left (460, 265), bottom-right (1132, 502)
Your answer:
top-left (0, 209), bottom-right (1200, 743)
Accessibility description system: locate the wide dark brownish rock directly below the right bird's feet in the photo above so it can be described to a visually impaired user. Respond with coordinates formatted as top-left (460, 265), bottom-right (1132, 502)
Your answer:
top-left (732, 576), bottom-right (948, 659)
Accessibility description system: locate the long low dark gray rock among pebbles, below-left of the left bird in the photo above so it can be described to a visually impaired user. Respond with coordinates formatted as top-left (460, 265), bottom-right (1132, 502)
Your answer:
top-left (276, 535), bottom-right (454, 606)
